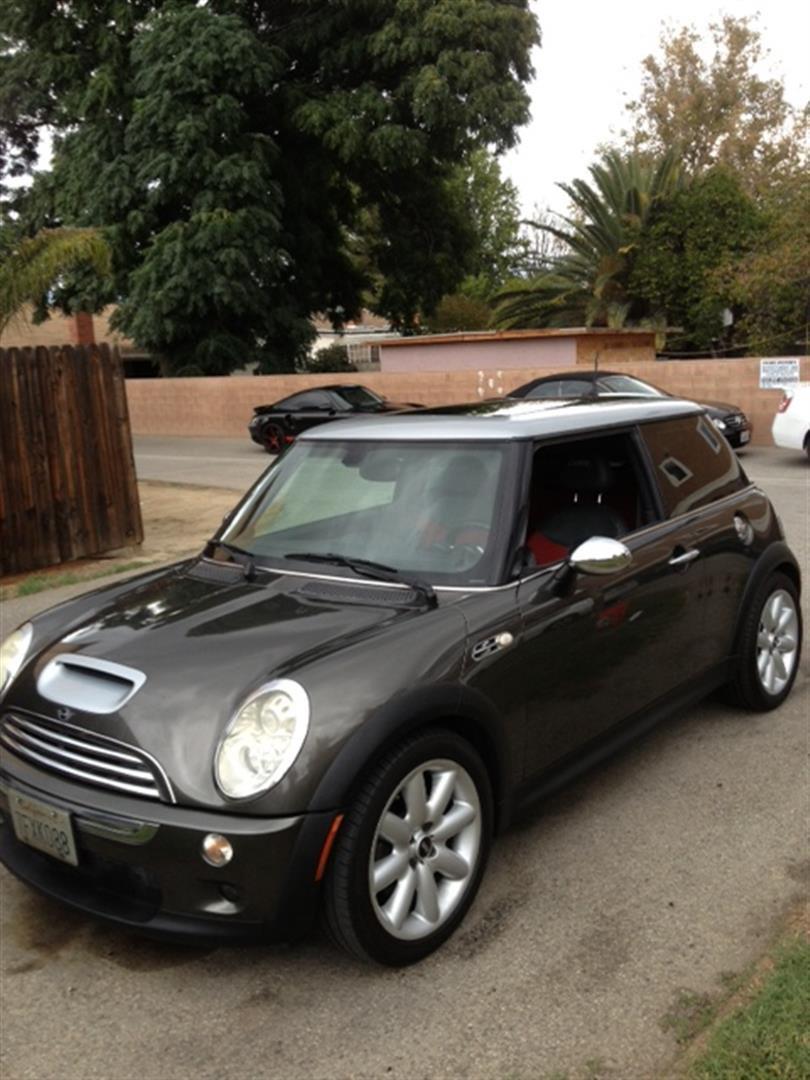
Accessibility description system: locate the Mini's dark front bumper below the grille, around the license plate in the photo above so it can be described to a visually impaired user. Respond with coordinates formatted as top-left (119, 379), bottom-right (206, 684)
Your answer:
top-left (0, 752), bottom-right (335, 943)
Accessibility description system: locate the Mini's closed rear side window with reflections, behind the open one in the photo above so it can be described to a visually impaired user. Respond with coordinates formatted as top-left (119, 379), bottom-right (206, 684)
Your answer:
top-left (640, 415), bottom-right (745, 517)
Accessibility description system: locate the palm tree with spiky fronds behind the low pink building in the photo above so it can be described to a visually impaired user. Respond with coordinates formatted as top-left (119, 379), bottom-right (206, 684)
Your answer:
top-left (496, 150), bottom-right (681, 328)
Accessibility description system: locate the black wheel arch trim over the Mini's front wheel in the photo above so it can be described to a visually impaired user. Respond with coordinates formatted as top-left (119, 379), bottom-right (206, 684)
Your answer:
top-left (309, 685), bottom-right (510, 829)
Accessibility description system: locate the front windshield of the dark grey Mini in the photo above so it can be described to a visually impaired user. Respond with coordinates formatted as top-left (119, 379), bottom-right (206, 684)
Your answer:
top-left (222, 440), bottom-right (508, 584)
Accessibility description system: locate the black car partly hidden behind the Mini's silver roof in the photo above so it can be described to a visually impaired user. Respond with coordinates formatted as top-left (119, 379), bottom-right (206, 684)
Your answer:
top-left (508, 370), bottom-right (751, 449)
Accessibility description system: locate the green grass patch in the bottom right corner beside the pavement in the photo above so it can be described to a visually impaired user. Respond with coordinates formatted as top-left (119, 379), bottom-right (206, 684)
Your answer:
top-left (688, 937), bottom-right (810, 1080)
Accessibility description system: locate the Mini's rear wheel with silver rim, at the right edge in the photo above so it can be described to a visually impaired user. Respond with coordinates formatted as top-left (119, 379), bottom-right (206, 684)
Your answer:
top-left (730, 573), bottom-right (801, 712)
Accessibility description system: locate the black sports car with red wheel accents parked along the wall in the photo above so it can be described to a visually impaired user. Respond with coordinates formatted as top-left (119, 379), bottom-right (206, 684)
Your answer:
top-left (247, 383), bottom-right (422, 454)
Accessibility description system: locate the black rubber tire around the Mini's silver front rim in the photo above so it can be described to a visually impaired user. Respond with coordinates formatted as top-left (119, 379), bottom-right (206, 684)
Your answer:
top-left (324, 728), bottom-right (492, 967)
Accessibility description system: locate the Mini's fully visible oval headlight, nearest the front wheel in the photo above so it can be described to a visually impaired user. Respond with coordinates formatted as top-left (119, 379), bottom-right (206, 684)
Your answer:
top-left (214, 678), bottom-right (309, 799)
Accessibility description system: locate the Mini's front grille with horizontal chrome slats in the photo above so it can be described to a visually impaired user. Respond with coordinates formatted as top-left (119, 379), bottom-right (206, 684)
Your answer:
top-left (0, 713), bottom-right (174, 802)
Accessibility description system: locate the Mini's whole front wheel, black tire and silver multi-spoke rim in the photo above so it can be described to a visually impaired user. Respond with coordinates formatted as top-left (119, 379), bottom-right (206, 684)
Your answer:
top-left (325, 729), bottom-right (492, 966)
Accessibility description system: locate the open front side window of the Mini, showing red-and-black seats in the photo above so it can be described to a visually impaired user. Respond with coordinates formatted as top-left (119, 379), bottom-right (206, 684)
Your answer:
top-left (526, 435), bottom-right (654, 566)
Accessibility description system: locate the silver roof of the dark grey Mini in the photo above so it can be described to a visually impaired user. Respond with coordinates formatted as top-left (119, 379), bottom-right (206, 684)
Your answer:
top-left (298, 397), bottom-right (703, 442)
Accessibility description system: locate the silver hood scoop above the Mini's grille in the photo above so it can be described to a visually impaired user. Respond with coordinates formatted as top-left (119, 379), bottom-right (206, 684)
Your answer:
top-left (37, 652), bottom-right (146, 714)
